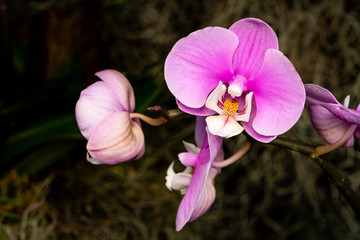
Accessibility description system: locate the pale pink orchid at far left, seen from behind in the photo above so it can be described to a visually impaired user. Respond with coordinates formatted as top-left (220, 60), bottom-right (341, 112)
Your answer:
top-left (75, 70), bottom-right (145, 164)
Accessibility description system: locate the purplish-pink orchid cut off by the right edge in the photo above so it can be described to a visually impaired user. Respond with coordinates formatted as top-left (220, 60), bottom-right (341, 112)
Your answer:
top-left (305, 84), bottom-right (360, 154)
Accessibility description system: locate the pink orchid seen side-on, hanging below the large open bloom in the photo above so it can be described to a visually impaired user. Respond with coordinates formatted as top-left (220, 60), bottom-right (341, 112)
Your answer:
top-left (166, 117), bottom-right (224, 231)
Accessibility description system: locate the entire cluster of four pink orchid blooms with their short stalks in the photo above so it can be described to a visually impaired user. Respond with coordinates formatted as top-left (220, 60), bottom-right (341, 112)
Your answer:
top-left (76, 18), bottom-right (360, 231)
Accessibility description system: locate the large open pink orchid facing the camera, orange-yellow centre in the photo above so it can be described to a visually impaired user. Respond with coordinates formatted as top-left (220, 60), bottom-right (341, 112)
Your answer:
top-left (165, 18), bottom-right (305, 142)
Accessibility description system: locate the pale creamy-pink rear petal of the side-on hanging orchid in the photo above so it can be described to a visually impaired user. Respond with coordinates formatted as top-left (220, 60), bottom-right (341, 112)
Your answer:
top-left (189, 168), bottom-right (217, 222)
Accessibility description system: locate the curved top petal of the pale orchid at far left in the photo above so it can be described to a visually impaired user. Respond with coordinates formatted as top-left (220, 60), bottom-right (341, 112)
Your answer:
top-left (95, 69), bottom-right (135, 112)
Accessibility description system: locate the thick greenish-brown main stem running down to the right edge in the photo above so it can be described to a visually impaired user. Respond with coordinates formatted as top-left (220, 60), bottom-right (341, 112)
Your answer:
top-left (270, 137), bottom-right (360, 219)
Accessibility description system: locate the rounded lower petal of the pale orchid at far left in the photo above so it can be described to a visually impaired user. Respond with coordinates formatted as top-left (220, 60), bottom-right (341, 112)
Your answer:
top-left (87, 112), bottom-right (145, 164)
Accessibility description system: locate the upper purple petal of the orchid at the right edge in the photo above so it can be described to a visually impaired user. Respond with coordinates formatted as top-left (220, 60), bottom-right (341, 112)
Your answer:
top-left (305, 84), bottom-right (339, 105)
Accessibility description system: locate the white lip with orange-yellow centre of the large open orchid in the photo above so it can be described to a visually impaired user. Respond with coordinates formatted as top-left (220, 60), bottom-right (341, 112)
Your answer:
top-left (205, 82), bottom-right (253, 138)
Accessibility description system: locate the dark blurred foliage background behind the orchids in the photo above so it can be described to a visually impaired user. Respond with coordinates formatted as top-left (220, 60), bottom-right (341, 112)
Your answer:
top-left (0, 0), bottom-right (360, 240)
